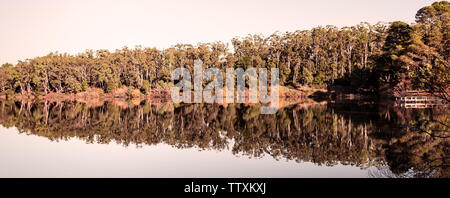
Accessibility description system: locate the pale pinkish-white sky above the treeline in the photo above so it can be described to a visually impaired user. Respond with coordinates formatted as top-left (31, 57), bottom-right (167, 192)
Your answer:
top-left (0, 0), bottom-right (434, 64)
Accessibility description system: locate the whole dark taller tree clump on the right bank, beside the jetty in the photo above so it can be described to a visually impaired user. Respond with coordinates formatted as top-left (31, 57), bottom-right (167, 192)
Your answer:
top-left (378, 1), bottom-right (450, 101)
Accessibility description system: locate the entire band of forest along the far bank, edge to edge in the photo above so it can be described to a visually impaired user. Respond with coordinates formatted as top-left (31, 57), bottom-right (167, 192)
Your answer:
top-left (0, 1), bottom-right (450, 101)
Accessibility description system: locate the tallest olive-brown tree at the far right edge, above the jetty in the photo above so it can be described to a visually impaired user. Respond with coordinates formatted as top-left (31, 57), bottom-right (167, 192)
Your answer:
top-left (402, 1), bottom-right (450, 101)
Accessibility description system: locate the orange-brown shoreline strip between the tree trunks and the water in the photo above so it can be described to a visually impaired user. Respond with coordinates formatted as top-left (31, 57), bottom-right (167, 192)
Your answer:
top-left (0, 86), bottom-right (384, 109)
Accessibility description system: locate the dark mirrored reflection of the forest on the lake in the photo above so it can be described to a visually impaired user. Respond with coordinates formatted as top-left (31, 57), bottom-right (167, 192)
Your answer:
top-left (0, 101), bottom-right (450, 177)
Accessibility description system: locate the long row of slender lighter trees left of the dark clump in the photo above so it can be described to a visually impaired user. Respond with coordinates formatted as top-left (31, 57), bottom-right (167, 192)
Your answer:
top-left (0, 24), bottom-right (384, 94)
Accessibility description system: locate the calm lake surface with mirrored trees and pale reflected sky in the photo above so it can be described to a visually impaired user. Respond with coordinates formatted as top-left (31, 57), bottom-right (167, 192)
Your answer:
top-left (0, 101), bottom-right (450, 177)
